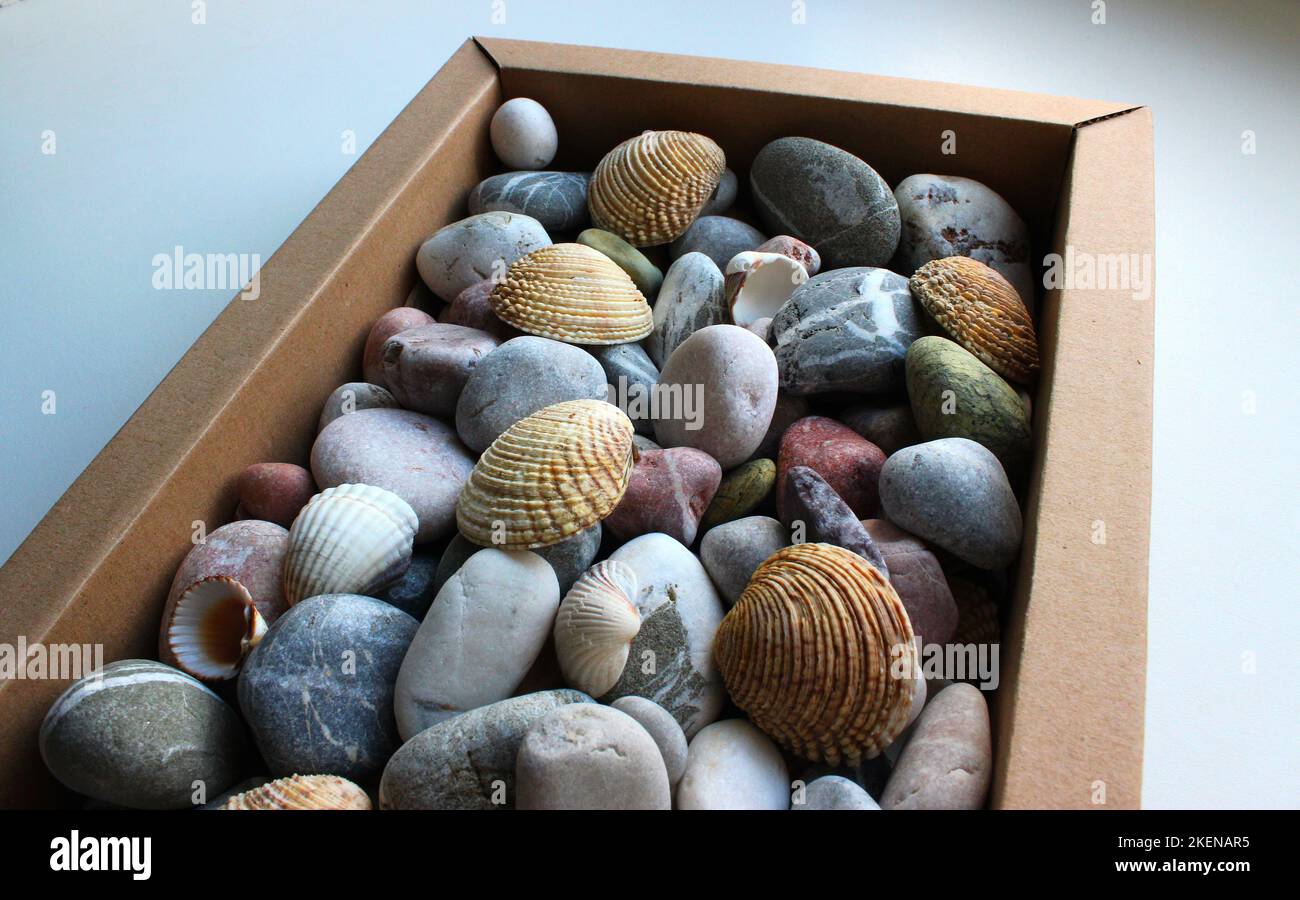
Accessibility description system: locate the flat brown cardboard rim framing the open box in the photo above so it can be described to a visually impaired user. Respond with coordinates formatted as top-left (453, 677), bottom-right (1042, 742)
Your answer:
top-left (0, 38), bottom-right (1153, 808)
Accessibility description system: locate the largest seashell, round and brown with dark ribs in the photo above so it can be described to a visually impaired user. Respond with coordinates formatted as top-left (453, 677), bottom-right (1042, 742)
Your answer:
top-left (714, 544), bottom-right (917, 766)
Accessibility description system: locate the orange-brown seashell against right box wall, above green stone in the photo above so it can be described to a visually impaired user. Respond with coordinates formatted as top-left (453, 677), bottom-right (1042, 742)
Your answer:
top-left (907, 256), bottom-right (1039, 382)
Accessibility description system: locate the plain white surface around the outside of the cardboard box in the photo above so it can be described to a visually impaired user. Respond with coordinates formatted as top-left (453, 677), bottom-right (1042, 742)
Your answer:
top-left (0, 0), bottom-right (1300, 808)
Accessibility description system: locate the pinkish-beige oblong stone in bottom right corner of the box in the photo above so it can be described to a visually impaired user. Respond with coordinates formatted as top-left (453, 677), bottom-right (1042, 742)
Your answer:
top-left (880, 683), bottom-right (993, 809)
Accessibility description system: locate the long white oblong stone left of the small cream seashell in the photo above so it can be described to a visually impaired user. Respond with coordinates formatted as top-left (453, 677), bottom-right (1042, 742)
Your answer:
top-left (393, 548), bottom-right (560, 740)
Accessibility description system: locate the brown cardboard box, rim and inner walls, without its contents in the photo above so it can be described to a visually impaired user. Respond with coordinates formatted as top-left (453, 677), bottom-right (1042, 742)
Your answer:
top-left (0, 39), bottom-right (1153, 808)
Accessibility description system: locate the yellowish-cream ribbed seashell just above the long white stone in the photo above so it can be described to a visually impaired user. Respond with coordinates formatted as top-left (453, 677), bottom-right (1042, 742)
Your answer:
top-left (456, 399), bottom-right (633, 550)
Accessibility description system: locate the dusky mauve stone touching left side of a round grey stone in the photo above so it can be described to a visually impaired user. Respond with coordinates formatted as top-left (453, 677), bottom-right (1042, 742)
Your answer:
top-left (384, 323), bottom-right (498, 417)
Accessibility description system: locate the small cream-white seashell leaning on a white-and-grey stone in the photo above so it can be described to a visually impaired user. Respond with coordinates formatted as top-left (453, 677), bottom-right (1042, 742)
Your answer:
top-left (554, 559), bottom-right (641, 697)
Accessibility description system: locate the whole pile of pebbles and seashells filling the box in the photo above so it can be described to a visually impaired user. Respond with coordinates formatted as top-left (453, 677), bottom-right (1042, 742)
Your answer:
top-left (40, 99), bottom-right (1039, 809)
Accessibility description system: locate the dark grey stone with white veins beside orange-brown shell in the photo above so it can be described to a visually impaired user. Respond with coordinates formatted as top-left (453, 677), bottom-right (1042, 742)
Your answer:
top-left (771, 268), bottom-right (923, 395)
